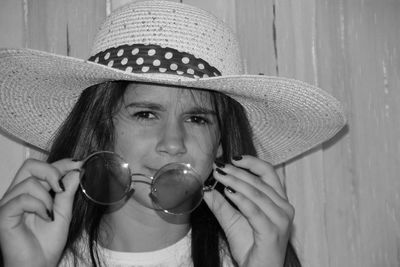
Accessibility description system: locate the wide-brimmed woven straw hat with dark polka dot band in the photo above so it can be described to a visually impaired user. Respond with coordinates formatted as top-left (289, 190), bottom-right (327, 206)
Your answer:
top-left (0, 1), bottom-right (345, 165)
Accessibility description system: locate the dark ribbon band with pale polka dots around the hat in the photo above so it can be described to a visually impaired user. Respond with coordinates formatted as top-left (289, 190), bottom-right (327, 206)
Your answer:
top-left (89, 44), bottom-right (221, 78)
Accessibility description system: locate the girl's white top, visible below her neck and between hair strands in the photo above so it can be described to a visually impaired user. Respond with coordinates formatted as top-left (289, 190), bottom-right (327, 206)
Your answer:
top-left (58, 231), bottom-right (233, 267)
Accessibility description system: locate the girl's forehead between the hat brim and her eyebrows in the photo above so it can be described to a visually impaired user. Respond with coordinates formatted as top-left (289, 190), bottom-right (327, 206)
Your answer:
top-left (124, 83), bottom-right (212, 108)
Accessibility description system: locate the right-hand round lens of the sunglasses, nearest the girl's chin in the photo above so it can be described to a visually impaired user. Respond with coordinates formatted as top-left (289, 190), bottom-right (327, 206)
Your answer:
top-left (150, 163), bottom-right (203, 214)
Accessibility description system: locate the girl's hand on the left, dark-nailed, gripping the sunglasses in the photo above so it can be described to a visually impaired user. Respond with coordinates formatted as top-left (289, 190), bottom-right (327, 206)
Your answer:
top-left (0, 159), bottom-right (81, 267)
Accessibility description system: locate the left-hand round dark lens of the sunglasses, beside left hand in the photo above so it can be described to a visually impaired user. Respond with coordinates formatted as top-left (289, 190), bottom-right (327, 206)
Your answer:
top-left (80, 152), bottom-right (131, 205)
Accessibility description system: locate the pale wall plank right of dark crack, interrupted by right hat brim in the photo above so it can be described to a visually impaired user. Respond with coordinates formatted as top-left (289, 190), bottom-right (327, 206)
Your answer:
top-left (274, 1), bottom-right (329, 266)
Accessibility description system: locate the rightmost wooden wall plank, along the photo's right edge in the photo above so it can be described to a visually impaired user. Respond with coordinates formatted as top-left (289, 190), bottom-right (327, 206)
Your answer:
top-left (344, 0), bottom-right (400, 266)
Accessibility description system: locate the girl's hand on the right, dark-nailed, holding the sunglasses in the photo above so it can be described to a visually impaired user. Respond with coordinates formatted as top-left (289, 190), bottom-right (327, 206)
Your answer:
top-left (204, 156), bottom-right (294, 267)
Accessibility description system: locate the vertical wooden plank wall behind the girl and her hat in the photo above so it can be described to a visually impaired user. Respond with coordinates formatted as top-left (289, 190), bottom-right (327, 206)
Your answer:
top-left (0, 0), bottom-right (400, 267)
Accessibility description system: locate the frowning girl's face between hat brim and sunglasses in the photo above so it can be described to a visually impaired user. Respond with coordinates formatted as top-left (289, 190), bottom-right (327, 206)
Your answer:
top-left (114, 84), bottom-right (222, 192)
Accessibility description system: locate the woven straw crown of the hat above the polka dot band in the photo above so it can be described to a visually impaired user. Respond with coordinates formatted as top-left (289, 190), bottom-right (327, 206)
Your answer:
top-left (91, 0), bottom-right (243, 75)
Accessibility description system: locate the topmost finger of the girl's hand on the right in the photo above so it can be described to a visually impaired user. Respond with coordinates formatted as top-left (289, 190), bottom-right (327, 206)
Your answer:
top-left (232, 155), bottom-right (287, 199)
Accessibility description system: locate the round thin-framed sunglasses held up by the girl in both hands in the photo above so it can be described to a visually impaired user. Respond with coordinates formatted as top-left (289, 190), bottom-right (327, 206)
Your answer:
top-left (80, 151), bottom-right (217, 215)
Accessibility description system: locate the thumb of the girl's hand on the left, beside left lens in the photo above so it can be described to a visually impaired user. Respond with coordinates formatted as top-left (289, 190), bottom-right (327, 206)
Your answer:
top-left (54, 170), bottom-right (79, 224)
